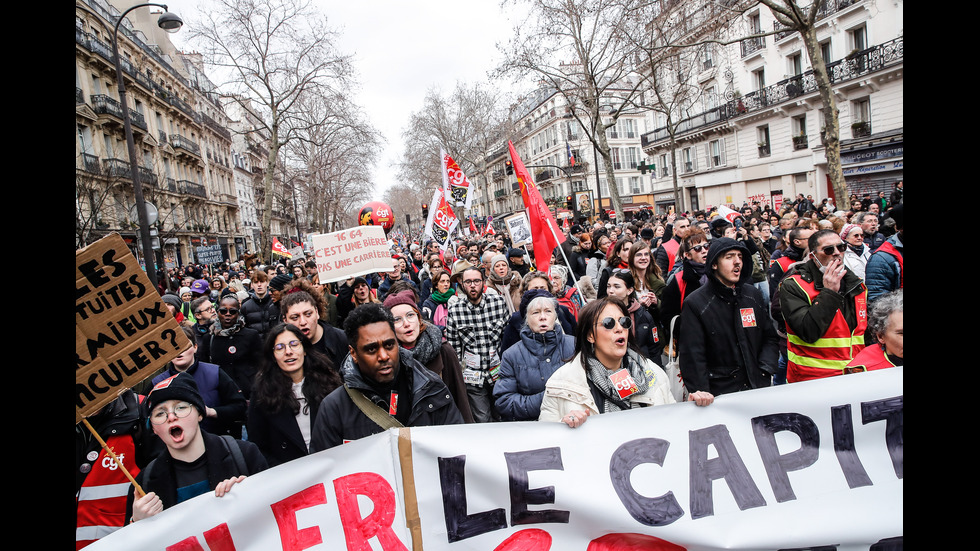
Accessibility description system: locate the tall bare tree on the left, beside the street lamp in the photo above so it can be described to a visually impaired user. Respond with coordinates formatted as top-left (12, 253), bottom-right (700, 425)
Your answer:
top-left (189, 0), bottom-right (352, 254)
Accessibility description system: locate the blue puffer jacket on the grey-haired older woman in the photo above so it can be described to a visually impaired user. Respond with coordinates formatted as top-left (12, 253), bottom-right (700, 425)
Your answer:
top-left (493, 323), bottom-right (575, 421)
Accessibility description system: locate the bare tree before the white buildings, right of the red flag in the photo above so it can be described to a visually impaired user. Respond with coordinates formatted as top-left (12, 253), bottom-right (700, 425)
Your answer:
top-left (498, 0), bottom-right (644, 216)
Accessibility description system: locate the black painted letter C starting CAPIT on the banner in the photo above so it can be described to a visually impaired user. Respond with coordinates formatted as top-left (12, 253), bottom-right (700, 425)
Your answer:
top-left (609, 438), bottom-right (684, 526)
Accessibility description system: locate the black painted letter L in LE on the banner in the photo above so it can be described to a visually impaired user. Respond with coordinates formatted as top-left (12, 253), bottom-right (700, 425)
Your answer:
top-left (439, 455), bottom-right (507, 543)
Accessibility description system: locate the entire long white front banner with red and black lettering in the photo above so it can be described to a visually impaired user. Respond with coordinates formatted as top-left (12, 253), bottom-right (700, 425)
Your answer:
top-left (93, 367), bottom-right (904, 551)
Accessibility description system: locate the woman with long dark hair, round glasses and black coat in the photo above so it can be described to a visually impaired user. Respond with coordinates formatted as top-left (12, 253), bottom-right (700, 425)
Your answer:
top-left (248, 323), bottom-right (342, 467)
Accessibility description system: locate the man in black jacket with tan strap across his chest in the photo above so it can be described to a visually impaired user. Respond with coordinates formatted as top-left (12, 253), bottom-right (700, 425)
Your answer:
top-left (310, 303), bottom-right (463, 453)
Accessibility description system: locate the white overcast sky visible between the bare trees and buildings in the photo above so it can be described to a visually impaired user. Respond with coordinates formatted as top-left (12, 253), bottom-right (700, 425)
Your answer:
top-left (167, 0), bottom-right (528, 203)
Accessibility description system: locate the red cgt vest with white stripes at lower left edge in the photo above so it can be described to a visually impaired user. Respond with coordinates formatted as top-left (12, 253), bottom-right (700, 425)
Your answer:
top-left (75, 434), bottom-right (139, 550)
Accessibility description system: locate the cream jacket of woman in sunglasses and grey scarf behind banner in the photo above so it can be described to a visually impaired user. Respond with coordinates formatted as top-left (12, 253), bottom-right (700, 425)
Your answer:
top-left (538, 354), bottom-right (675, 422)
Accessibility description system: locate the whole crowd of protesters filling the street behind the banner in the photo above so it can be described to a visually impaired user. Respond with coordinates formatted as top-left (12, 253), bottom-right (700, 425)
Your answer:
top-left (76, 184), bottom-right (904, 548)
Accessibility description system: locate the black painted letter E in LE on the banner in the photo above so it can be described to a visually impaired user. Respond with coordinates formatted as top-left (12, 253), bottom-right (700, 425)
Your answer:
top-left (504, 448), bottom-right (568, 526)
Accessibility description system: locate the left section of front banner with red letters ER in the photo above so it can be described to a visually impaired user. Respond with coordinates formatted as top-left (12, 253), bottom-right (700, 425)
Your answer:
top-left (86, 432), bottom-right (411, 551)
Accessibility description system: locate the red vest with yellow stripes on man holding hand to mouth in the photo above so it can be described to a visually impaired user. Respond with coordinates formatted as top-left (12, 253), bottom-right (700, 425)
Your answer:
top-left (784, 275), bottom-right (868, 383)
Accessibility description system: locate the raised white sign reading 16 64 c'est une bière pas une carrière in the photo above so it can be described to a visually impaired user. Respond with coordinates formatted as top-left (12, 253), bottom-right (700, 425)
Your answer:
top-left (313, 226), bottom-right (391, 283)
